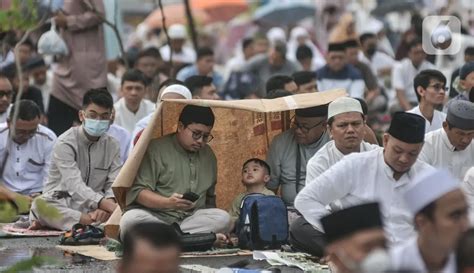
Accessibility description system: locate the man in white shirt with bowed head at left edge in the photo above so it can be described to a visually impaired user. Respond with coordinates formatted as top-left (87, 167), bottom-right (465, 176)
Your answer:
top-left (0, 100), bottom-right (56, 196)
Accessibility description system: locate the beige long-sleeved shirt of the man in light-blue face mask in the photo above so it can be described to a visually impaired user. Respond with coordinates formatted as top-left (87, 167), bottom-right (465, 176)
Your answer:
top-left (43, 126), bottom-right (122, 211)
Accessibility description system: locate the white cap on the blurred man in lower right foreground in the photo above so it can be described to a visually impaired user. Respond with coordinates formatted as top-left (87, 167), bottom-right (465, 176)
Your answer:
top-left (403, 169), bottom-right (460, 216)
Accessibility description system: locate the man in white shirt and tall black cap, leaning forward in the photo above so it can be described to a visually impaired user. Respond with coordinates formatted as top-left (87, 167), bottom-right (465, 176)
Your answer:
top-left (291, 112), bottom-right (432, 253)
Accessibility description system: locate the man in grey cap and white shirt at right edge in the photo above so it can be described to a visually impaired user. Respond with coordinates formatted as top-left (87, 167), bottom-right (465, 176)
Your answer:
top-left (420, 100), bottom-right (474, 180)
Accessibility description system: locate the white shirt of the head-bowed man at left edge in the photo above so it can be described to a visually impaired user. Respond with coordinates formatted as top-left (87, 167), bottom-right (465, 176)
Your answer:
top-left (0, 122), bottom-right (56, 195)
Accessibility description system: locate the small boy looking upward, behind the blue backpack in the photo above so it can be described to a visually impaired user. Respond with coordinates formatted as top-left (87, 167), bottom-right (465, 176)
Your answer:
top-left (229, 158), bottom-right (275, 225)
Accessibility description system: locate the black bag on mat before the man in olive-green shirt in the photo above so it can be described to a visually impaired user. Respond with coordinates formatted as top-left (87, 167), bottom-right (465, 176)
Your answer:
top-left (173, 223), bottom-right (216, 252)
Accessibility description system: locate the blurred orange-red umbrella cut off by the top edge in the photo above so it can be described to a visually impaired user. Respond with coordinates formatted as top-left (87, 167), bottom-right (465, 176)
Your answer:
top-left (191, 0), bottom-right (248, 22)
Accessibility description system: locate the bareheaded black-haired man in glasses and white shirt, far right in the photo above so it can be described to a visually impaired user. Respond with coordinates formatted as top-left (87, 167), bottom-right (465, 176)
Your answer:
top-left (407, 69), bottom-right (448, 133)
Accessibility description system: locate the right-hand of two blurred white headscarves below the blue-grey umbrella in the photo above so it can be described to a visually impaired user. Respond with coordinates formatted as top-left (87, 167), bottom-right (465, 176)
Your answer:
top-left (286, 26), bottom-right (326, 70)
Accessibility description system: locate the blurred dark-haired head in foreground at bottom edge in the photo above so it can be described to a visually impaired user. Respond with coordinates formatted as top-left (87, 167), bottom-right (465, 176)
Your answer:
top-left (117, 223), bottom-right (181, 273)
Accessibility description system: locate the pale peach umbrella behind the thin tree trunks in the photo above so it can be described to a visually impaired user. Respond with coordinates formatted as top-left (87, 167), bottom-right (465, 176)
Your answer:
top-left (145, 4), bottom-right (210, 28)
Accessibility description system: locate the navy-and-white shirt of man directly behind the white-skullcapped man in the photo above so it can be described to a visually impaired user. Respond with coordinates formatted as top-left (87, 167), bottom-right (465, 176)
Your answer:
top-left (316, 64), bottom-right (365, 98)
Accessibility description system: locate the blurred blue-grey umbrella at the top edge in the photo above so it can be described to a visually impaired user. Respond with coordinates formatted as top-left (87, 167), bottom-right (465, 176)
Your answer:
top-left (254, 0), bottom-right (316, 25)
